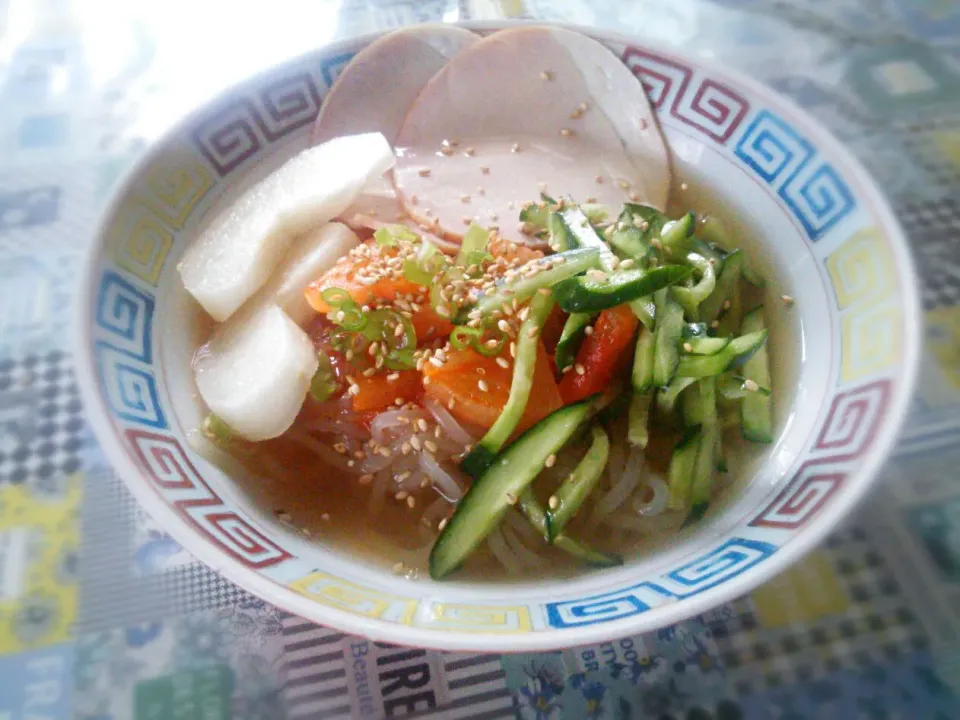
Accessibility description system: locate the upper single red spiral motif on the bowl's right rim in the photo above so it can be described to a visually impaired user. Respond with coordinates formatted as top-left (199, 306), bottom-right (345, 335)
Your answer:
top-left (813, 379), bottom-right (893, 461)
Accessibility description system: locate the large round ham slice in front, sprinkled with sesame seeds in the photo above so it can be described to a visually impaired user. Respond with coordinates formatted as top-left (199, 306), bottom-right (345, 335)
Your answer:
top-left (393, 27), bottom-right (670, 242)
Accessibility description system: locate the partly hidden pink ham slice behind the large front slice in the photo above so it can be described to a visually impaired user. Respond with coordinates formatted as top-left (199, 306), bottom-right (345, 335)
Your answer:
top-left (313, 24), bottom-right (480, 143)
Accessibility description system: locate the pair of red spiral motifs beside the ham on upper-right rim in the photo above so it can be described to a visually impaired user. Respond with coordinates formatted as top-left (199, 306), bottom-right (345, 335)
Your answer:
top-left (623, 47), bottom-right (750, 145)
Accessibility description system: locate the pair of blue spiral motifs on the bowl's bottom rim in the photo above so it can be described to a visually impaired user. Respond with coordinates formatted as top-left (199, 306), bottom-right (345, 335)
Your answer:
top-left (547, 538), bottom-right (777, 628)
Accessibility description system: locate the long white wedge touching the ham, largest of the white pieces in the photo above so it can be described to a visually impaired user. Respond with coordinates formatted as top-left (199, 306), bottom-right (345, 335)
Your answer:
top-left (179, 133), bottom-right (394, 321)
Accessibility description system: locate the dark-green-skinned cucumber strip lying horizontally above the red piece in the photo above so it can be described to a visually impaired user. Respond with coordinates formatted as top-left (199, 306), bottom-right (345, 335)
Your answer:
top-left (554, 265), bottom-right (691, 312)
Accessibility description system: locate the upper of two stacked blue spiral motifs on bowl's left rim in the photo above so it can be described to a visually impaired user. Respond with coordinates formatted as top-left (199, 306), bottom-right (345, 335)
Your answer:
top-left (94, 270), bottom-right (153, 364)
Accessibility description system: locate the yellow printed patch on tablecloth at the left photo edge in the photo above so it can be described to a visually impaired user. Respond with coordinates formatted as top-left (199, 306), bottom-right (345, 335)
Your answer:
top-left (0, 473), bottom-right (83, 655)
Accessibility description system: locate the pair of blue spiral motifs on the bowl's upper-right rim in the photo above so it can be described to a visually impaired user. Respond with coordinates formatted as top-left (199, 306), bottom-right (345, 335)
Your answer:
top-left (735, 110), bottom-right (857, 242)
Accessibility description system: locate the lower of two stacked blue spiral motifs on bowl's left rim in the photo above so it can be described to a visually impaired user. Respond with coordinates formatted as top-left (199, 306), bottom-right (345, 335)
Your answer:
top-left (96, 342), bottom-right (167, 429)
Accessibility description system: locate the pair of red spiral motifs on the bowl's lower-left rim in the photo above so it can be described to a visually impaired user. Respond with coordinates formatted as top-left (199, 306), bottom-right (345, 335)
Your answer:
top-left (124, 429), bottom-right (291, 569)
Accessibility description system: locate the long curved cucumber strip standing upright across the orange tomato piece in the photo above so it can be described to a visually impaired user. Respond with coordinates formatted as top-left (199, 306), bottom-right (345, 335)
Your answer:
top-left (460, 292), bottom-right (553, 478)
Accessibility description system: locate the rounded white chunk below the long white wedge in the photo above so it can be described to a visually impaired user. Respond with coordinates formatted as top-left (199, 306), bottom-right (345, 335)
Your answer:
top-left (194, 305), bottom-right (319, 441)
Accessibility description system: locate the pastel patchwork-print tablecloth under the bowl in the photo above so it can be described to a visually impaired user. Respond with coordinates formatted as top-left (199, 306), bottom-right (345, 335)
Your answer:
top-left (0, 0), bottom-right (960, 720)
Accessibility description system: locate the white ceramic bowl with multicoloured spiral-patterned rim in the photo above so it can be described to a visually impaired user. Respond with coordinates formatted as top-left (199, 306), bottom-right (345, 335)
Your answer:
top-left (76, 23), bottom-right (920, 651)
